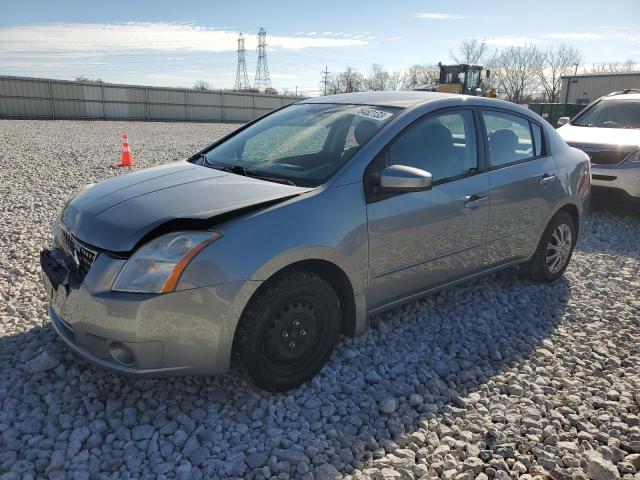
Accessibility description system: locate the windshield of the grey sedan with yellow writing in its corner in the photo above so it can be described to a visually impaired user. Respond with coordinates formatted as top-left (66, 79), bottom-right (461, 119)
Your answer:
top-left (197, 103), bottom-right (401, 187)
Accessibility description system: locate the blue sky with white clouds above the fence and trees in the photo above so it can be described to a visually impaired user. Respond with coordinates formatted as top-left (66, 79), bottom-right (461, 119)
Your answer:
top-left (0, 0), bottom-right (640, 92)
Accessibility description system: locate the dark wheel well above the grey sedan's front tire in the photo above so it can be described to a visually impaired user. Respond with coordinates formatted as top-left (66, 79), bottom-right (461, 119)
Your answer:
top-left (254, 260), bottom-right (356, 337)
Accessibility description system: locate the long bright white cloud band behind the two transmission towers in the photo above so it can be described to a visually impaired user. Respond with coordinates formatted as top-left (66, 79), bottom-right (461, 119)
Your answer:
top-left (0, 22), bottom-right (368, 54)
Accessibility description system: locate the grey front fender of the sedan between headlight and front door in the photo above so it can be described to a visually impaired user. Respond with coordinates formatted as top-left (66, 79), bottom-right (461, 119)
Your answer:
top-left (178, 183), bottom-right (368, 294)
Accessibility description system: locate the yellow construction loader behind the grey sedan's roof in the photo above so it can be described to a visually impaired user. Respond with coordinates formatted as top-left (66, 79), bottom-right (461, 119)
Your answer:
top-left (416, 63), bottom-right (496, 98)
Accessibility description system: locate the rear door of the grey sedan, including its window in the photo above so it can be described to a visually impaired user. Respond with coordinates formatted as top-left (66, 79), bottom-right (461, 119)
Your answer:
top-left (481, 109), bottom-right (561, 265)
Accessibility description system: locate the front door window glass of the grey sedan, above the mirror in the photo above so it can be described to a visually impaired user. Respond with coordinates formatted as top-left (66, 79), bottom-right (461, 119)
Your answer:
top-left (388, 110), bottom-right (478, 182)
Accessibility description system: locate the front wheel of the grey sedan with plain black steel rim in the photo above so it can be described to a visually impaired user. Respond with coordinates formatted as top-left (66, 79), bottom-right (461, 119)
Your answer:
top-left (233, 270), bottom-right (341, 392)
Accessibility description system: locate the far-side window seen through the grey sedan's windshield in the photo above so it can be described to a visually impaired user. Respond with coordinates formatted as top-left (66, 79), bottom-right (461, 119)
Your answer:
top-left (242, 125), bottom-right (329, 162)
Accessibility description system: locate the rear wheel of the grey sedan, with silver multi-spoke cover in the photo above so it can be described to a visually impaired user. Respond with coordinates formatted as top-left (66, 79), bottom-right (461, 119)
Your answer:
top-left (524, 211), bottom-right (577, 283)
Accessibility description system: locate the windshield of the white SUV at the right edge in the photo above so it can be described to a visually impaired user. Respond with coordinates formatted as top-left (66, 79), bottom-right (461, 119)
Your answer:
top-left (572, 99), bottom-right (640, 128)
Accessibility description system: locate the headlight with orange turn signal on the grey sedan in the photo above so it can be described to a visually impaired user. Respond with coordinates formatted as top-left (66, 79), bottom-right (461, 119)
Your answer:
top-left (112, 231), bottom-right (222, 293)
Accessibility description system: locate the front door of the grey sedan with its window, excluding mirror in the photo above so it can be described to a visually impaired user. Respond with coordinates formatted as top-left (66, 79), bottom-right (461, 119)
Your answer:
top-left (367, 109), bottom-right (489, 308)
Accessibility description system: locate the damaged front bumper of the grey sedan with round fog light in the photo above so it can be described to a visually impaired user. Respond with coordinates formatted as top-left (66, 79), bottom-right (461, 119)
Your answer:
top-left (40, 248), bottom-right (245, 376)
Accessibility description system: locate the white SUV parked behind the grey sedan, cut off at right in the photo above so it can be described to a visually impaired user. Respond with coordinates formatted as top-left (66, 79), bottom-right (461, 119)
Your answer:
top-left (558, 90), bottom-right (640, 200)
